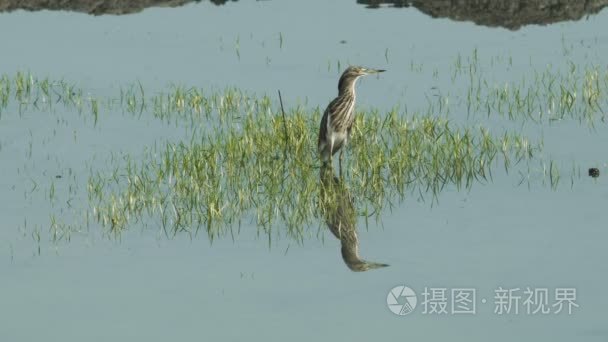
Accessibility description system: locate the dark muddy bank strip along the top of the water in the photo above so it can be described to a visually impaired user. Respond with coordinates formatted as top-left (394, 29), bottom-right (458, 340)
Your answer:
top-left (0, 0), bottom-right (608, 30)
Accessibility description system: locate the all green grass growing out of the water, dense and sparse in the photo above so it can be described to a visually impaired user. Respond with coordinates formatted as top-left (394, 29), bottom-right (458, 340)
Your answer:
top-left (0, 52), bottom-right (608, 241)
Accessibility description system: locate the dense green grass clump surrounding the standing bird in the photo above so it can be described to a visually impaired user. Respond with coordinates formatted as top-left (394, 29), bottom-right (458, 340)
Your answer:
top-left (89, 93), bottom-right (534, 241)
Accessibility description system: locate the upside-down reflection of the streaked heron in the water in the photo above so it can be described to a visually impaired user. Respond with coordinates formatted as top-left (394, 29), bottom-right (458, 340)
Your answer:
top-left (321, 167), bottom-right (388, 272)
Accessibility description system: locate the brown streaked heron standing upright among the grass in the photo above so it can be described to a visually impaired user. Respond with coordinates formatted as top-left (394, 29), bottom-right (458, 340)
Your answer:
top-left (319, 66), bottom-right (384, 170)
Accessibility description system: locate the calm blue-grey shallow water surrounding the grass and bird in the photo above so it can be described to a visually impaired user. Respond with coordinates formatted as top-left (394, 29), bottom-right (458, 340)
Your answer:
top-left (0, 1), bottom-right (608, 341)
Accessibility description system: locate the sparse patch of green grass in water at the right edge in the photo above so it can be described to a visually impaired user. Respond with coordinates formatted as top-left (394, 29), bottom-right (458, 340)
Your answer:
top-left (458, 63), bottom-right (608, 126)
